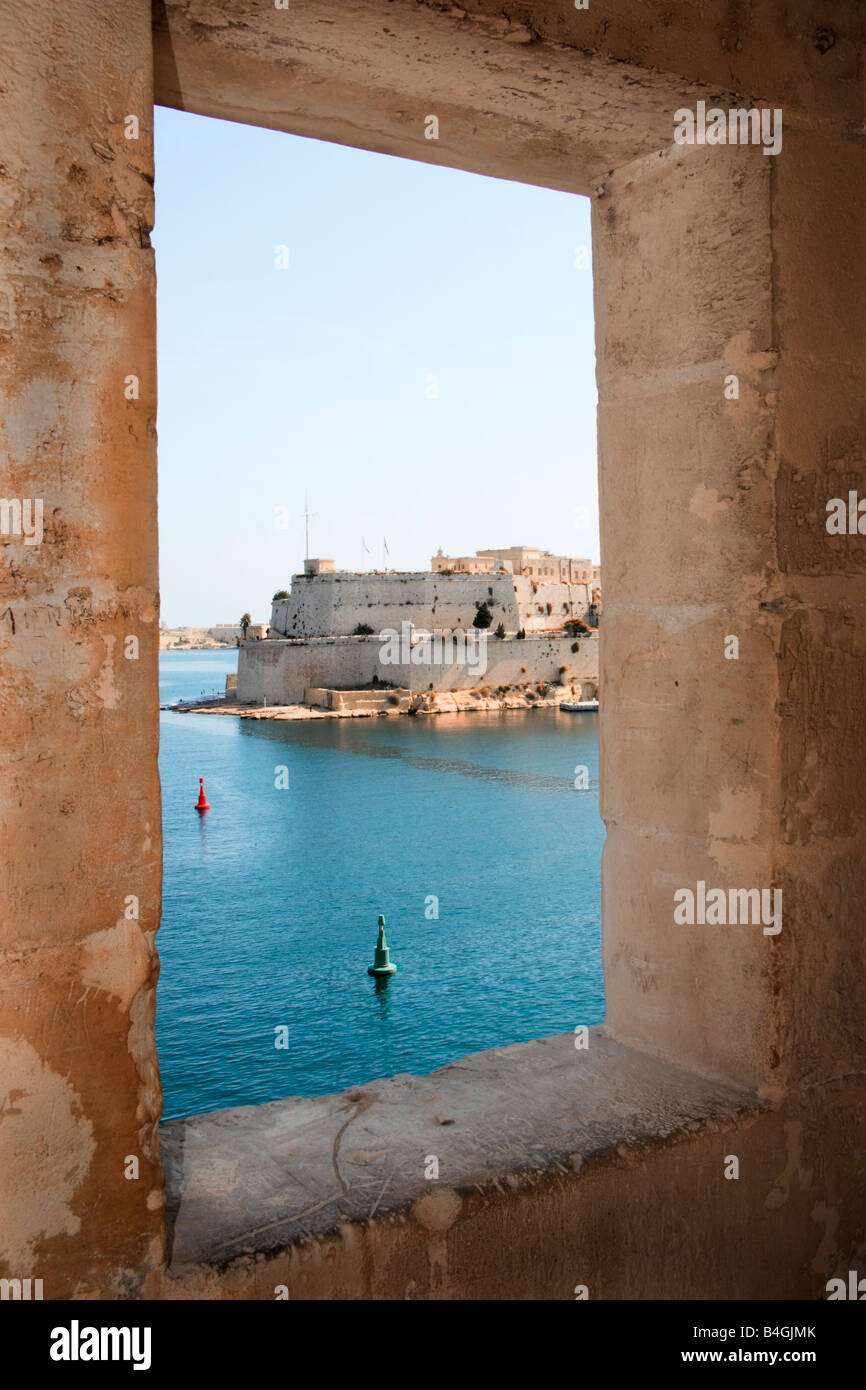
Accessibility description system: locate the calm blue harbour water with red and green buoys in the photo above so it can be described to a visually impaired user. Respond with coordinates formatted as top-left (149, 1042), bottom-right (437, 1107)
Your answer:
top-left (157, 652), bottom-right (603, 1118)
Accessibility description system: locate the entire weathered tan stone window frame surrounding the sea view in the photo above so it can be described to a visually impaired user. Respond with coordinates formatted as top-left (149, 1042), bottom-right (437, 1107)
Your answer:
top-left (8, 0), bottom-right (866, 1297)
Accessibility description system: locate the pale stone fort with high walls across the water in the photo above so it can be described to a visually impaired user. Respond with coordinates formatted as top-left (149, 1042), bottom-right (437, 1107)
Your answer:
top-left (238, 546), bottom-right (601, 705)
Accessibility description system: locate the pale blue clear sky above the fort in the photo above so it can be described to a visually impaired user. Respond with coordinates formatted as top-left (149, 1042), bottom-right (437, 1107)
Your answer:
top-left (153, 108), bottom-right (598, 626)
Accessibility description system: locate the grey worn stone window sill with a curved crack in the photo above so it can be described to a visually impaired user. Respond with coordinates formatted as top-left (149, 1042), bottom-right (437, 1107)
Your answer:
top-left (161, 1029), bottom-right (765, 1273)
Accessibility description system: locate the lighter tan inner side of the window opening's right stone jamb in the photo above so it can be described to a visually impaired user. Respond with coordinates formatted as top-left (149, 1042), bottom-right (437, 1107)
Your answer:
top-left (594, 146), bottom-right (784, 1087)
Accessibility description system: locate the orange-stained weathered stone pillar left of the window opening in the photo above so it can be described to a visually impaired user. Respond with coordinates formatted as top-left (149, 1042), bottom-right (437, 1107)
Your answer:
top-left (0, 0), bottom-right (163, 1298)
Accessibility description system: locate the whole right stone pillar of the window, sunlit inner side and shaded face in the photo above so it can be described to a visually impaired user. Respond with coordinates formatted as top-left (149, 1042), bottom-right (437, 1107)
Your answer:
top-left (594, 122), bottom-right (866, 1117)
